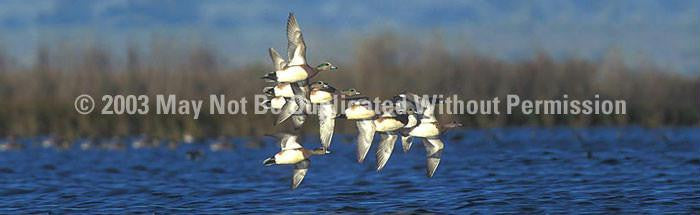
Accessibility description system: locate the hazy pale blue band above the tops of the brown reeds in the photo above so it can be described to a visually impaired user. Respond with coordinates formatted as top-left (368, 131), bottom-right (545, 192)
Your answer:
top-left (0, 0), bottom-right (700, 73)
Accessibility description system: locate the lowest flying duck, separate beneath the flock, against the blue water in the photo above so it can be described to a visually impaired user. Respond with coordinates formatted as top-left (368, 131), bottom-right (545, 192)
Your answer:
top-left (263, 133), bottom-right (330, 190)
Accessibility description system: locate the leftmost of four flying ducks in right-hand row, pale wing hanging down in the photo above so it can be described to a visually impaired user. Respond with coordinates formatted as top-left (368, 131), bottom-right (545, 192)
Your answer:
top-left (309, 81), bottom-right (360, 149)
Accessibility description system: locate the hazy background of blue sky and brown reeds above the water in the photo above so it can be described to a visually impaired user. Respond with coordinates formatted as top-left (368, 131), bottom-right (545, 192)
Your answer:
top-left (0, 0), bottom-right (700, 138)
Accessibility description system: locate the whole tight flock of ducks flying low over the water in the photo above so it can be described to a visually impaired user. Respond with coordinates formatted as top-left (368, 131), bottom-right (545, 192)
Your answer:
top-left (263, 13), bottom-right (461, 189)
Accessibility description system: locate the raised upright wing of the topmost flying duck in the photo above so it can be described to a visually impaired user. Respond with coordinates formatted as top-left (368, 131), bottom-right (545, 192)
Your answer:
top-left (287, 13), bottom-right (306, 66)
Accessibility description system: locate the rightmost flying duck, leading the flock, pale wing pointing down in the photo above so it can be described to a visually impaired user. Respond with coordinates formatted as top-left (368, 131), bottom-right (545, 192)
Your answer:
top-left (401, 93), bottom-right (462, 178)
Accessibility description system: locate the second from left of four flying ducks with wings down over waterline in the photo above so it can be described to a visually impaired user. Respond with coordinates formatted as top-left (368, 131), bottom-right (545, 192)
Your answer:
top-left (336, 97), bottom-right (376, 163)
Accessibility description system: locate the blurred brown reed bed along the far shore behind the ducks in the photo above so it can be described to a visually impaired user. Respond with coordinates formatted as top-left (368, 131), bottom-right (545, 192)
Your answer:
top-left (0, 33), bottom-right (700, 139)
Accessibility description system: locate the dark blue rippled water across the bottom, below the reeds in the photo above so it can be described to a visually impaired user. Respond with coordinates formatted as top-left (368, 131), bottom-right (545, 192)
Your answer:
top-left (0, 127), bottom-right (700, 213)
